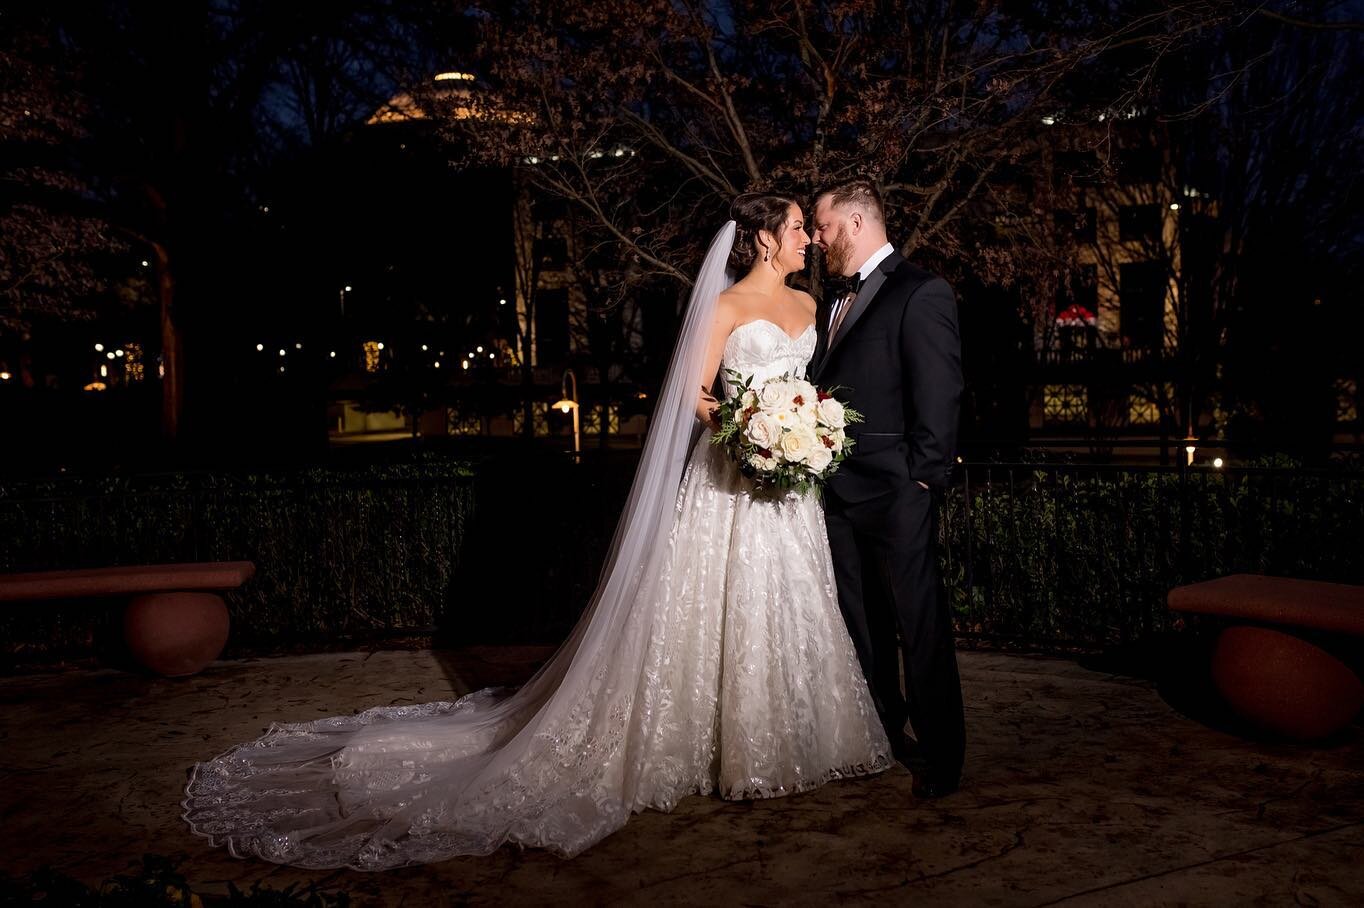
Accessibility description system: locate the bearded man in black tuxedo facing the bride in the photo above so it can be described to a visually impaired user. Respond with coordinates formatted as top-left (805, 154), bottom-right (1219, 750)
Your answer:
top-left (810, 174), bottom-right (966, 798)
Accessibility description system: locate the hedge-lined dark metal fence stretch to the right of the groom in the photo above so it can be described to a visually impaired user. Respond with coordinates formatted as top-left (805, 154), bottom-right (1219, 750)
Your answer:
top-left (940, 464), bottom-right (1364, 649)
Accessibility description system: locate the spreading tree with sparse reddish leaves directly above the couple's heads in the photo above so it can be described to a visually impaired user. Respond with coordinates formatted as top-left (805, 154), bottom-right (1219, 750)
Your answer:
top-left (449, 0), bottom-right (1234, 297)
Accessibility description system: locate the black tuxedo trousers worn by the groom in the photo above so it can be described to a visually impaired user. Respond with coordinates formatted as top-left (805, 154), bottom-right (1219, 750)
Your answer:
top-left (824, 483), bottom-right (966, 784)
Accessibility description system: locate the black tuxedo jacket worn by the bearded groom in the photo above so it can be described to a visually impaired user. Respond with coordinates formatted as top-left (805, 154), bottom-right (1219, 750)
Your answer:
top-left (809, 252), bottom-right (963, 503)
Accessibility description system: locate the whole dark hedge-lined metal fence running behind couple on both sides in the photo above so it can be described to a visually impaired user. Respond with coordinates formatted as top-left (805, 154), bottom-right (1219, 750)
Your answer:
top-left (0, 454), bottom-right (1364, 657)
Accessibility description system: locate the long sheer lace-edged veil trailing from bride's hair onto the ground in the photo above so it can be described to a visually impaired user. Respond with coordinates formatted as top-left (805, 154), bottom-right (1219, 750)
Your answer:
top-left (183, 221), bottom-right (735, 870)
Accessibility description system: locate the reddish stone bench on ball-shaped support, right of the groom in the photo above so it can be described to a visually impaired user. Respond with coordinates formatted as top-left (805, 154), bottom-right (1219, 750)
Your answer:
top-left (1168, 574), bottom-right (1364, 740)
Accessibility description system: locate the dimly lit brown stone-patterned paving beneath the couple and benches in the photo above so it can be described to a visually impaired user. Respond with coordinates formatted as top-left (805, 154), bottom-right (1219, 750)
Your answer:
top-left (0, 648), bottom-right (1364, 907)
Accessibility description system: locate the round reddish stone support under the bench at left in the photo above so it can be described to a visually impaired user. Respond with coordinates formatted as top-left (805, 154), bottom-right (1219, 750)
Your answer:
top-left (123, 593), bottom-right (229, 678)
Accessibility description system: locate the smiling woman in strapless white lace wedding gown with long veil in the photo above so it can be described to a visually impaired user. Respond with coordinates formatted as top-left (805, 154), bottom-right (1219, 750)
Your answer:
top-left (184, 194), bottom-right (889, 870)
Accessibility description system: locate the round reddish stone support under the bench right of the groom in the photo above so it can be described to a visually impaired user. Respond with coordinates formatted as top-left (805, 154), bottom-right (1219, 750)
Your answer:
top-left (1213, 624), bottom-right (1364, 740)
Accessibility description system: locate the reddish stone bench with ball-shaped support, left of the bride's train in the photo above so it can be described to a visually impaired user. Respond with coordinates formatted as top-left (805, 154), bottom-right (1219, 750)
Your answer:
top-left (0, 562), bottom-right (255, 678)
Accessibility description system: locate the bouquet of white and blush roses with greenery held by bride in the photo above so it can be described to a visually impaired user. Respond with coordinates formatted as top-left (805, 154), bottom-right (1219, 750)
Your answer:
top-left (711, 369), bottom-right (862, 495)
